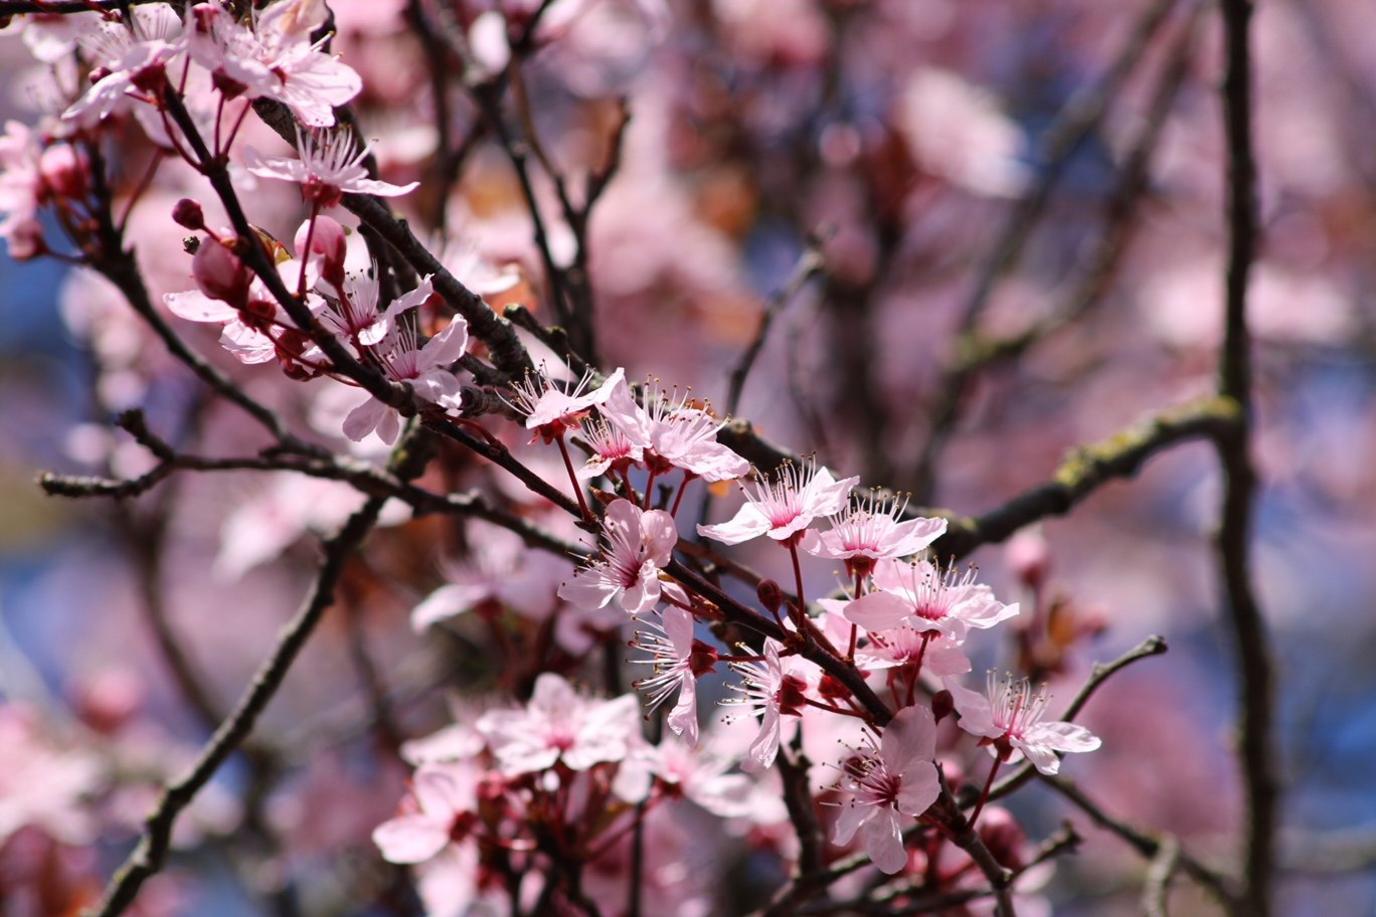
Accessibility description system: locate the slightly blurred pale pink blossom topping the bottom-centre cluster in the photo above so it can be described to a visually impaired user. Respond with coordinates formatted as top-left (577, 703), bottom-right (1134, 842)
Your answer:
top-left (477, 672), bottom-right (640, 775)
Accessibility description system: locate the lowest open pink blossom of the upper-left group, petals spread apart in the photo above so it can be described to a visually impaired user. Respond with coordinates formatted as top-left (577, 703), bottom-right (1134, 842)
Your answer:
top-left (344, 315), bottom-right (468, 445)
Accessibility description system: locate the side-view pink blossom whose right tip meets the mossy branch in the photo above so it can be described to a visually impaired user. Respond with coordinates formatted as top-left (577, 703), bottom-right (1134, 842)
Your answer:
top-left (799, 493), bottom-right (947, 576)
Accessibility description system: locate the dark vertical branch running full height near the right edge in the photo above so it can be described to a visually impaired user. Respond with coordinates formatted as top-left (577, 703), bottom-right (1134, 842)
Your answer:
top-left (1216, 0), bottom-right (1280, 917)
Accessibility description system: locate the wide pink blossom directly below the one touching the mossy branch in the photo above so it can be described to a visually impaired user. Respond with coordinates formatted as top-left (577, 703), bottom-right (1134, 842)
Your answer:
top-left (845, 560), bottom-right (1018, 643)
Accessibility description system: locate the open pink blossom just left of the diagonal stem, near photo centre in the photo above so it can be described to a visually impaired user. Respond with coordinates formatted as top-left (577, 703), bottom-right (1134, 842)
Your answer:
top-left (559, 500), bottom-right (674, 614)
